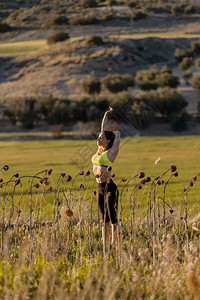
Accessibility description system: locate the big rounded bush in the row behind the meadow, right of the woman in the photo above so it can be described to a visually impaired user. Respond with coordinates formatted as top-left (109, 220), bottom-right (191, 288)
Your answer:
top-left (141, 88), bottom-right (187, 119)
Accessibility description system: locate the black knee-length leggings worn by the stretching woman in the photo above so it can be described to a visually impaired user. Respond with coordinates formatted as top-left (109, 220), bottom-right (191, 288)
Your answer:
top-left (97, 179), bottom-right (119, 224)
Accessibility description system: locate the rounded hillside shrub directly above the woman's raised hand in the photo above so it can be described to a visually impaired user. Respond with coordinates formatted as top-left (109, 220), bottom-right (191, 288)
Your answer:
top-left (101, 74), bottom-right (134, 93)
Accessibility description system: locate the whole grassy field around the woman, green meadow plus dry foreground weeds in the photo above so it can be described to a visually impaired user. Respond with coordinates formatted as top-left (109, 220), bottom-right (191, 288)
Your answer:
top-left (0, 136), bottom-right (200, 300)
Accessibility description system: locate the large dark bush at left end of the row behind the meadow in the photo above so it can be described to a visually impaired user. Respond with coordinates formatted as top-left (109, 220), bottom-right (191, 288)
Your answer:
top-left (5, 98), bottom-right (36, 129)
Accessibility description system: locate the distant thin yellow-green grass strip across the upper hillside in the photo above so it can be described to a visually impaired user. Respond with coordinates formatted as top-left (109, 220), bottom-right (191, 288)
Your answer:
top-left (0, 32), bottom-right (200, 54)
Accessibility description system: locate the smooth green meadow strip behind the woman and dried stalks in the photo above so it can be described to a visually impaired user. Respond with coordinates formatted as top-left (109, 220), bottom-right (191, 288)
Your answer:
top-left (0, 136), bottom-right (200, 216)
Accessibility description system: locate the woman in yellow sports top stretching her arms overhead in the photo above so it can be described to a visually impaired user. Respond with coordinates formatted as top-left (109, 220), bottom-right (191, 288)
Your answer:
top-left (92, 107), bottom-right (120, 243)
